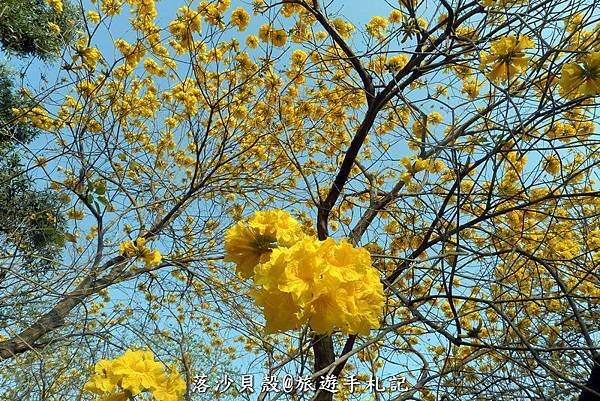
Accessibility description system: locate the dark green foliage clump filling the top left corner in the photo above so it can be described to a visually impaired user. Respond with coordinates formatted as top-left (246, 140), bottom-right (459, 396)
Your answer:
top-left (0, 0), bottom-right (79, 60)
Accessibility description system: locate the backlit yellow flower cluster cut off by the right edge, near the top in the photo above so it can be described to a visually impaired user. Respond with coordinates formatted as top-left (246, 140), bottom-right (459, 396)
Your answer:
top-left (559, 51), bottom-right (600, 97)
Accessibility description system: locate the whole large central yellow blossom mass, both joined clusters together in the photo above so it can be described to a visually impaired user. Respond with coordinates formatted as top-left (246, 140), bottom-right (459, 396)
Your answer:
top-left (225, 210), bottom-right (384, 334)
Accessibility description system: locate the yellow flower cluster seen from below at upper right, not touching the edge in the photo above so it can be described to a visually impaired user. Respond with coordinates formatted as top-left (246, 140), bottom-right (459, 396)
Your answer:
top-left (481, 36), bottom-right (534, 82)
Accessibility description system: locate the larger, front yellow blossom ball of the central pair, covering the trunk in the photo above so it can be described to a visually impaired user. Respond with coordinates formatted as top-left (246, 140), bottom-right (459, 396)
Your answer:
top-left (252, 237), bottom-right (384, 334)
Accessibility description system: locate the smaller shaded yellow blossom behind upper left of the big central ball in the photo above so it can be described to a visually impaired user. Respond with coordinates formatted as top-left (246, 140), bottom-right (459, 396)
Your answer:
top-left (225, 210), bottom-right (304, 278)
